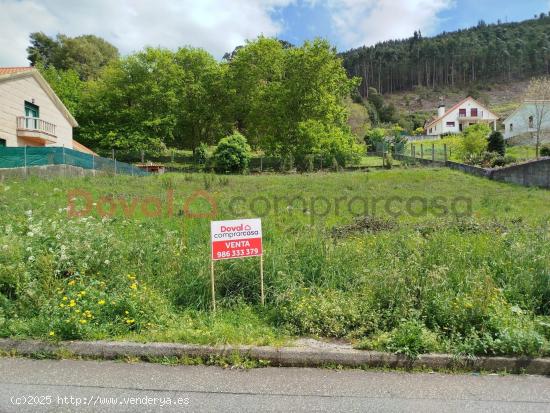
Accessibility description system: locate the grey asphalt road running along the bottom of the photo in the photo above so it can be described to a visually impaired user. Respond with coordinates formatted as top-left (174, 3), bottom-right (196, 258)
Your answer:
top-left (0, 358), bottom-right (550, 413)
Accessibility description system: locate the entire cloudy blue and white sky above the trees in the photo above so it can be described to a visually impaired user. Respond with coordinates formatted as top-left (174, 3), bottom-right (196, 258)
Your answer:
top-left (0, 0), bottom-right (550, 66)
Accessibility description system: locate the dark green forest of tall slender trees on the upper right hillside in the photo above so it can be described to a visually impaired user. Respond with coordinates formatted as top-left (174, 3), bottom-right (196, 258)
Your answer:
top-left (342, 13), bottom-right (550, 96)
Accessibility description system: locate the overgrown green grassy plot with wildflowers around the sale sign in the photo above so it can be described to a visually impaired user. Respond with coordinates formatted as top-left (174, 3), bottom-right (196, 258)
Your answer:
top-left (0, 169), bottom-right (550, 356)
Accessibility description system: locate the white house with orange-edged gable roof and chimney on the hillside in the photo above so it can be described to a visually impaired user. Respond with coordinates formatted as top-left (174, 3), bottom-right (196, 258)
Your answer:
top-left (425, 96), bottom-right (498, 136)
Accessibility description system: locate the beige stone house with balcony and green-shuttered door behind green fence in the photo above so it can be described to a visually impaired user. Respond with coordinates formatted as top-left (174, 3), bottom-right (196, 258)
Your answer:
top-left (0, 67), bottom-right (93, 153)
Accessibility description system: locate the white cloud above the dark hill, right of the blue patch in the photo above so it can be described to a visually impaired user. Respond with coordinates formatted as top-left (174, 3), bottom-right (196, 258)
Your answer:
top-left (327, 0), bottom-right (454, 48)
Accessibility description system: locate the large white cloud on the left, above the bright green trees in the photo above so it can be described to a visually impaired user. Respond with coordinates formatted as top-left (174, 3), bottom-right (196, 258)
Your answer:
top-left (0, 0), bottom-right (294, 66)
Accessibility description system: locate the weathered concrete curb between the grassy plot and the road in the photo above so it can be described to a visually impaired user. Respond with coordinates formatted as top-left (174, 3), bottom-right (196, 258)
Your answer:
top-left (0, 339), bottom-right (550, 375)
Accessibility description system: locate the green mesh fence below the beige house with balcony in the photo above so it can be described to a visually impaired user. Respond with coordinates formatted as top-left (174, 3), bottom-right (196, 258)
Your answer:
top-left (0, 146), bottom-right (149, 176)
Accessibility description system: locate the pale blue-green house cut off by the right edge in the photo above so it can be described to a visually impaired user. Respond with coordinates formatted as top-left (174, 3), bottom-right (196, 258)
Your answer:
top-left (504, 100), bottom-right (550, 139)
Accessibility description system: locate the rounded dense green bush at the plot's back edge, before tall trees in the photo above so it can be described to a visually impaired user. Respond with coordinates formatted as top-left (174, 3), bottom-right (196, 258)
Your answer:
top-left (214, 132), bottom-right (252, 173)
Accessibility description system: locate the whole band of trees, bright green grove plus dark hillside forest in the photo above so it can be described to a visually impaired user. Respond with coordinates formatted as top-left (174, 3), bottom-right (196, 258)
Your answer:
top-left (27, 13), bottom-right (550, 165)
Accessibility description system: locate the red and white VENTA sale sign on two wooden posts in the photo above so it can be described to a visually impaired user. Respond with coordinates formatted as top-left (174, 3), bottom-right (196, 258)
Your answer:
top-left (210, 219), bottom-right (265, 311)
